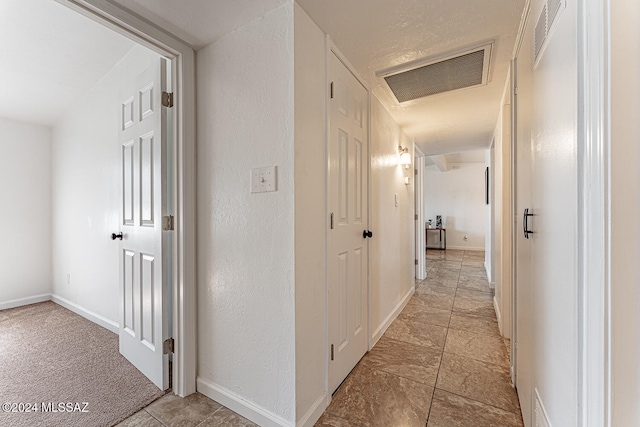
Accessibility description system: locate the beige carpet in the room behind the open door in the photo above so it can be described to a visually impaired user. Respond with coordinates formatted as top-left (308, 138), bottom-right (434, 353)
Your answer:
top-left (0, 302), bottom-right (164, 427)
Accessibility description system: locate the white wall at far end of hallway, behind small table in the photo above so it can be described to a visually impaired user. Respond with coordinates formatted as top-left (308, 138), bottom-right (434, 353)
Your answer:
top-left (424, 163), bottom-right (487, 250)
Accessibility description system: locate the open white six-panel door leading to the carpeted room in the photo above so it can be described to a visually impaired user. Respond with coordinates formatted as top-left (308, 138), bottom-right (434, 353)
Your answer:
top-left (118, 60), bottom-right (169, 390)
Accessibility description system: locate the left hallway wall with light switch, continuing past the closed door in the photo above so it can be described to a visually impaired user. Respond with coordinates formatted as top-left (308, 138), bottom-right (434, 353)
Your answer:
top-left (197, 3), bottom-right (414, 425)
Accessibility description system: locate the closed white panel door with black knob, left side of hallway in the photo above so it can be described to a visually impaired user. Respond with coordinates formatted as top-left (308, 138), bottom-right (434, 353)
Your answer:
top-left (327, 52), bottom-right (369, 392)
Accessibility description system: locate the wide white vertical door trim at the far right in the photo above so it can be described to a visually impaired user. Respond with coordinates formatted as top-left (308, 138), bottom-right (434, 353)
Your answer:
top-left (578, 0), bottom-right (612, 426)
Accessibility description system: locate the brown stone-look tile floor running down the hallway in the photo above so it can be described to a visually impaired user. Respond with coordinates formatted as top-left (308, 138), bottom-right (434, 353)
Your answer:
top-left (316, 250), bottom-right (522, 427)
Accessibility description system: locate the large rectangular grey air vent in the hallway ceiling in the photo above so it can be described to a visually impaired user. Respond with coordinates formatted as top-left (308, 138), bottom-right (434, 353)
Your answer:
top-left (376, 43), bottom-right (493, 102)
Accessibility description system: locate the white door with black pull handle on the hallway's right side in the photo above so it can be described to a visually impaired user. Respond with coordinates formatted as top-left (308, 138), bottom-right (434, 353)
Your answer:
top-left (515, 0), bottom-right (579, 427)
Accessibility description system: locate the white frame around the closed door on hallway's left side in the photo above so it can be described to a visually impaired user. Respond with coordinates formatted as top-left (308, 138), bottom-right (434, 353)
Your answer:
top-left (324, 34), bottom-right (372, 406)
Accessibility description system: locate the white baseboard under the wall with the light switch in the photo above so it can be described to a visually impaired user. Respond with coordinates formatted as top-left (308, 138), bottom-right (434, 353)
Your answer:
top-left (196, 377), bottom-right (293, 427)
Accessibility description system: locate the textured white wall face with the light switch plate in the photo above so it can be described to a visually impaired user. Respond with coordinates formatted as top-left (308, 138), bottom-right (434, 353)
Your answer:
top-left (197, 3), bottom-right (296, 424)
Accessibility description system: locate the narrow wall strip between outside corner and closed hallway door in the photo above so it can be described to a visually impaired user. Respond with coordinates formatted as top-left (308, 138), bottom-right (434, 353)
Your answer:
top-left (294, 3), bottom-right (327, 422)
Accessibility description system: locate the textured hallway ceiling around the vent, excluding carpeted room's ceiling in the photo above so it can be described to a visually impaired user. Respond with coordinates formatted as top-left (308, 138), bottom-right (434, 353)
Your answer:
top-left (116, 0), bottom-right (525, 155)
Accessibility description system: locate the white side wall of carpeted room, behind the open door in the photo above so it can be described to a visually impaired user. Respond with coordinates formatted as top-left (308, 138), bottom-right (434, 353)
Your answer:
top-left (51, 46), bottom-right (158, 323)
